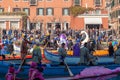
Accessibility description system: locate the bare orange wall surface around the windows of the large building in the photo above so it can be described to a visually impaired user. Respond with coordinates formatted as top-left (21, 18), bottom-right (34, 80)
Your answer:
top-left (0, 0), bottom-right (108, 30)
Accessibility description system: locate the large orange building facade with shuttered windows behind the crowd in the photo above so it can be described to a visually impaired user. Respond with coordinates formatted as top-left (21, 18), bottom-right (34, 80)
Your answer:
top-left (0, 0), bottom-right (108, 31)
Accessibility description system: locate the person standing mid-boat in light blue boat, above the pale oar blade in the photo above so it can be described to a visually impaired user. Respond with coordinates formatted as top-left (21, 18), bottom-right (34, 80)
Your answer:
top-left (58, 43), bottom-right (67, 64)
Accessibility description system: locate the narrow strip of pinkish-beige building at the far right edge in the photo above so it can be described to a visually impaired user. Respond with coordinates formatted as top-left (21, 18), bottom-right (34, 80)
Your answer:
top-left (110, 0), bottom-right (120, 34)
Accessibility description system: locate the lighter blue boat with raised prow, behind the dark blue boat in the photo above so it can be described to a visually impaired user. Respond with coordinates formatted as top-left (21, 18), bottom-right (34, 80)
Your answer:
top-left (44, 49), bottom-right (114, 64)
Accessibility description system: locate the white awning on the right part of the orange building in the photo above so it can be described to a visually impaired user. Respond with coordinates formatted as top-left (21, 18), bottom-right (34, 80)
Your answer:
top-left (84, 18), bottom-right (102, 24)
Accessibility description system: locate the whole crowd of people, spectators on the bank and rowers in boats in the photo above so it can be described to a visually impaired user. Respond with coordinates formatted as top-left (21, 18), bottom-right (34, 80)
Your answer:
top-left (0, 29), bottom-right (120, 80)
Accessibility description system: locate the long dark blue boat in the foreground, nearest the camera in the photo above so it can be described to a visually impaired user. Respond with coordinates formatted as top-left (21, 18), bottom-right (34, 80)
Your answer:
top-left (0, 61), bottom-right (120, 80)
